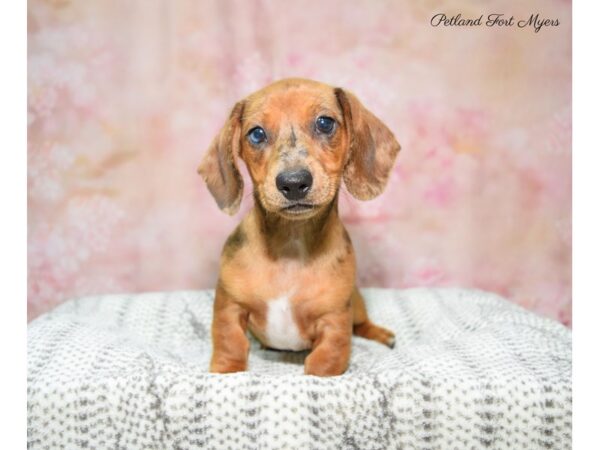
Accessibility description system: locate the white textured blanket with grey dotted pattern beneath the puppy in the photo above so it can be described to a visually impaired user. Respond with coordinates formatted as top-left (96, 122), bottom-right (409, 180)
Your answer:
top-left (28, 289), bottom-right (571, 450)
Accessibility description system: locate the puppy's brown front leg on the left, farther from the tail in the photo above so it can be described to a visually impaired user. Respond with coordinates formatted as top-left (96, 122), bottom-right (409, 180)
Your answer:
top-left (210, 284), bottom-right (250, 373)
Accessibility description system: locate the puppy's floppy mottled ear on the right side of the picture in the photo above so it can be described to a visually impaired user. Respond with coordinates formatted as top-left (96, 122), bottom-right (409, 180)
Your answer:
top-left (335, 88), bottom-right (400, 200)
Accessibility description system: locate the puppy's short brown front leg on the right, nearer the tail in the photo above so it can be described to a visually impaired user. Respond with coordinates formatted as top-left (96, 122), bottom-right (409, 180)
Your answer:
top-left (304, 309), bottom-right (352, 377)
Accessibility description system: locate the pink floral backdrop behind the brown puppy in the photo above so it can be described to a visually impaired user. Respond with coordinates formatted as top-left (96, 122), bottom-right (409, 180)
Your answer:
top-left (27, 0), bottom-right (571, 325)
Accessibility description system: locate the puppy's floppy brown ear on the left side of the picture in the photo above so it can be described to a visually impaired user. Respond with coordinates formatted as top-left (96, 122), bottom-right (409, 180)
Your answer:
top-left (198, 102), bottom-right (244, 215)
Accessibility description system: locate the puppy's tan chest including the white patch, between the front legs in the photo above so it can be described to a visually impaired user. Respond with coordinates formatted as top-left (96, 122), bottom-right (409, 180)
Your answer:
top-left (227, 241), bottom-right (353, 351)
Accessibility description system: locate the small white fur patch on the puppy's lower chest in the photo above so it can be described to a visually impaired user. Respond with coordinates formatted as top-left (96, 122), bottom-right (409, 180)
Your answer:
top-left (265, 295), bottom-right (310, 351)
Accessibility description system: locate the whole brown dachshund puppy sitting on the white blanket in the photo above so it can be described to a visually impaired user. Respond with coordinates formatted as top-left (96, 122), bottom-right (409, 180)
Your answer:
top-left (198, 79), bottom-right (400, 376)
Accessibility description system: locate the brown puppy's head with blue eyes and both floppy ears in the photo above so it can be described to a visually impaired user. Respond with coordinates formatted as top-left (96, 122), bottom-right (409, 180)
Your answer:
top-left (198, 79), bottom-right (400, 219)
